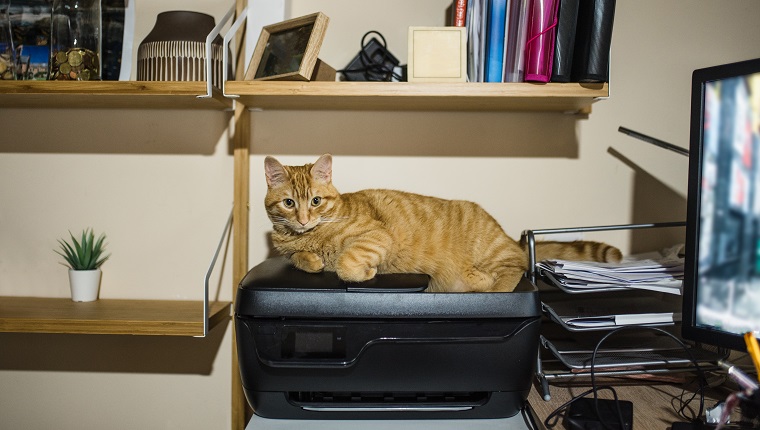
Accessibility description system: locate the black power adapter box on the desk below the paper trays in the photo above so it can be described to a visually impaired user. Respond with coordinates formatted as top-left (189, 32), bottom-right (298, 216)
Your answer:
top-left (564, 397), bottom-right (633, 430)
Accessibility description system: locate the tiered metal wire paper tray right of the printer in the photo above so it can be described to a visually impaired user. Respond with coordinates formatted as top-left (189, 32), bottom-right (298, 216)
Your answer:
top-left (522, 222), bottom-right (728, 400)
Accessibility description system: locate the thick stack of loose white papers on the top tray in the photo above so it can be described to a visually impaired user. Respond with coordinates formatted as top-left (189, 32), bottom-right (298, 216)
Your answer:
top-left (537, 257), bottom-right (683, 294)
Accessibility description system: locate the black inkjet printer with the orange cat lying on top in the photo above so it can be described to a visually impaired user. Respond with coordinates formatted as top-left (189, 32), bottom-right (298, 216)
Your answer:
top-left (235, 257), bottom-right (541, 419)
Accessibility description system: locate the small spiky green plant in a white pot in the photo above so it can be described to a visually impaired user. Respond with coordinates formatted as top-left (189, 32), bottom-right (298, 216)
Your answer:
top-left (55, 229), bottom-right (110, 302)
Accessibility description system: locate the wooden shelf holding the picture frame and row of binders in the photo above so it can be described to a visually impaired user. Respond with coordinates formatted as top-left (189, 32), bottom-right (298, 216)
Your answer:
top-left (225, 81), bottom-right (609, 113)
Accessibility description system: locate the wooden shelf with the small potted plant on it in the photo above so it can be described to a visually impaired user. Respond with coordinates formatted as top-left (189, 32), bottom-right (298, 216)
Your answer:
top-left (0, 296), bottom-right (230, 336)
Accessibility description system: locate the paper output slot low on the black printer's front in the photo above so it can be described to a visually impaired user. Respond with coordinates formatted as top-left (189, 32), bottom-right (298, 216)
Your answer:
top-left (288, 391), bottom-right (489, 412)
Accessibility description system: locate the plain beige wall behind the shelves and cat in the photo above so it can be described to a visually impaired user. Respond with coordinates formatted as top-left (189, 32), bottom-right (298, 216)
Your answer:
top-left (0, 0), bottom-right (760, 430)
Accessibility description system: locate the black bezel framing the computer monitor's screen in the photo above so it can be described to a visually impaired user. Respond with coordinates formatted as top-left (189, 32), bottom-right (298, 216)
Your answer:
top-left (681, 58), bottom-right (760, 351)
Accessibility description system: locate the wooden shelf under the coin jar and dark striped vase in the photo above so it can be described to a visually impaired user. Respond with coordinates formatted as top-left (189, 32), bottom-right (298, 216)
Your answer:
top-left (0, 81), bottom-right (232, 110)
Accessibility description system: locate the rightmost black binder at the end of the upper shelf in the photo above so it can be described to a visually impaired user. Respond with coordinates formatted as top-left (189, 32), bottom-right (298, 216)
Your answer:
top-left (571, 0), bottom-right (615, 82)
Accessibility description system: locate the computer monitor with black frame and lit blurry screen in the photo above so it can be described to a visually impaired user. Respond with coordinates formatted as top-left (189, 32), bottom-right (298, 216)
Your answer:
top-left (682, 59), bottom-right (760, 350)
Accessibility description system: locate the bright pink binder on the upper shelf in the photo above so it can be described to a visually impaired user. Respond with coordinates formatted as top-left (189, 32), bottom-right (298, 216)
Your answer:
top-left (525, 0), bottom-right (559, 82)
